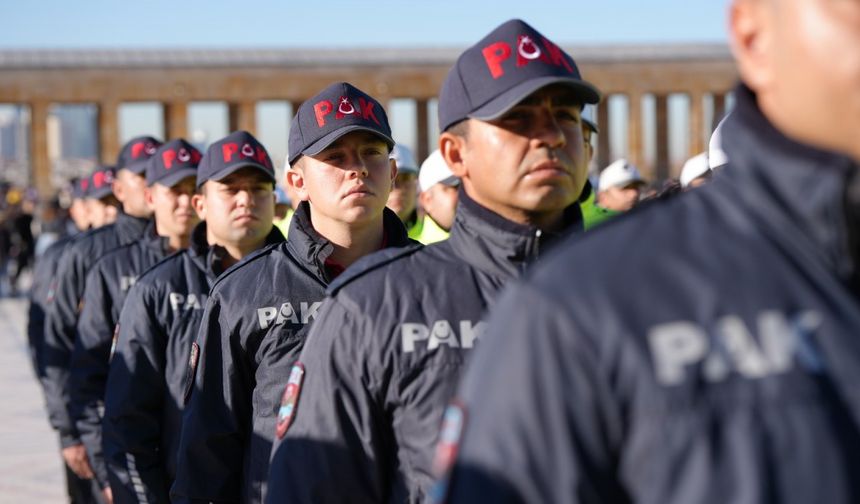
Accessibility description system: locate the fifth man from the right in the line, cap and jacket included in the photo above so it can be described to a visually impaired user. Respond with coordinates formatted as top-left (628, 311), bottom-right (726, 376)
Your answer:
top-left (69, 139), bottom-right (201, 500)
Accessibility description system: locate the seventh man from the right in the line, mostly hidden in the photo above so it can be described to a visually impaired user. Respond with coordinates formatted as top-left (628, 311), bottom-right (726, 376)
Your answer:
top-left (27, 171), bottom-right (108, 502)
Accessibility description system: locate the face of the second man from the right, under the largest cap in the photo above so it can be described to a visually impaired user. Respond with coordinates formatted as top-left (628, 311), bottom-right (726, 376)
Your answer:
top-left (442, 86), bottom-right (587, 225)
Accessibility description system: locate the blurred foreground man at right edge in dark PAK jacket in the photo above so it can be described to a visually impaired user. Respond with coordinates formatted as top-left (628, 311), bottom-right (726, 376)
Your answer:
top-left (440, 0), bottom-right (860, 504)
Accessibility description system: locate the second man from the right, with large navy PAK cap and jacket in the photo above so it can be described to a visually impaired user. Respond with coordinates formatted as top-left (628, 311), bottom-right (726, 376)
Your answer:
top-left (269, 20), bottom-right (599, 503)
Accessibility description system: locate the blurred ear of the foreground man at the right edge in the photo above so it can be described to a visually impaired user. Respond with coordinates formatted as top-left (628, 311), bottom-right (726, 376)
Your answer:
top-left (729, 0), bottom-right (778, 92)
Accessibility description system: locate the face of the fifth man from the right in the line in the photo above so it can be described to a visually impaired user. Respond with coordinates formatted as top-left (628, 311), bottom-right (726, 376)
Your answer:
top-left (147, 177), bottom-right (199, 241)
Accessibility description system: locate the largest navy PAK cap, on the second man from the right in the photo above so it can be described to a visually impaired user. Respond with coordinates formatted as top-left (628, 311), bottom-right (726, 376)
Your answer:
top-left (439, 19), bottom-right (600, 131)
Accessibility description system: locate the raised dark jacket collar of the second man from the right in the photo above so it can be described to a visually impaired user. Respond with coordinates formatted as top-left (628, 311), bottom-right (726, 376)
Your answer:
top-left (448, 188), bottom-right (582, 278)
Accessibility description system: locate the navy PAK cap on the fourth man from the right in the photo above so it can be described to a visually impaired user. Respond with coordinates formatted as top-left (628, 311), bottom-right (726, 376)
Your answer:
top-left (197, 130), bottom-right (275, 188)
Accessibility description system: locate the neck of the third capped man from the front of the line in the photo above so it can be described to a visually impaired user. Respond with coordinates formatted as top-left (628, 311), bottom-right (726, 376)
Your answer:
top-left (311, 210), bottom-right (384, 268)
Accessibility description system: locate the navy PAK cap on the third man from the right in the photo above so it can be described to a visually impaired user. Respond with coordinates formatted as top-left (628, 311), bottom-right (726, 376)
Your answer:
top-left (288, 82), bottom-right (394, 166)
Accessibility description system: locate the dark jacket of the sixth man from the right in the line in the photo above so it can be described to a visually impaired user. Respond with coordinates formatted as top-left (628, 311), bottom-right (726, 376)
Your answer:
top-left (39, 213), bottom-right (149, 446)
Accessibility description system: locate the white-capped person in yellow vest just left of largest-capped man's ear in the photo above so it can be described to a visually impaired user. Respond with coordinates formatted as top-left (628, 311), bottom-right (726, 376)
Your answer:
top-left (409, 149), bottom-right (460, 245)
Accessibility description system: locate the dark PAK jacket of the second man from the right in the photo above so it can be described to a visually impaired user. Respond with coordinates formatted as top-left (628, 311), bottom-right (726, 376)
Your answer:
top-left (267, 191), bottom-right (581, 503)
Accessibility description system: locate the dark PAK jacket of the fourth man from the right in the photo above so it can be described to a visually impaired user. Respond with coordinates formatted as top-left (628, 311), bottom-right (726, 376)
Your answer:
top-left (103, 223), bottom-right (283, 504)
